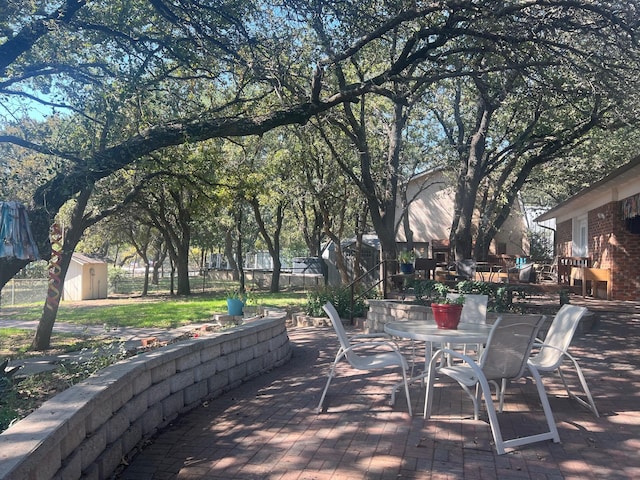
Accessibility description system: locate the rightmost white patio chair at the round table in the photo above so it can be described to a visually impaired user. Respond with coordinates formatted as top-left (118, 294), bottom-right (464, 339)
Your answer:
top-left (529, 303), bottom-right (600, 417)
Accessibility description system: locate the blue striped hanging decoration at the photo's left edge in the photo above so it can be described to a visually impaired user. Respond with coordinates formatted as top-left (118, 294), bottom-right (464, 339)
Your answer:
top-left (0, 202), bottom-right (40, 260)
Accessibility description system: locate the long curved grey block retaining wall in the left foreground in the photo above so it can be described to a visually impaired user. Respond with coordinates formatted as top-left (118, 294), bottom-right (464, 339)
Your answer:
top-left (0, 314), bottom-right (292, 480)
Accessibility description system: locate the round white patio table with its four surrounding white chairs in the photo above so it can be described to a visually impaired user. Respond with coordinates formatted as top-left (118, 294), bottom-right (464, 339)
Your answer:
top-left (317, 295), bottom-right (599, 454)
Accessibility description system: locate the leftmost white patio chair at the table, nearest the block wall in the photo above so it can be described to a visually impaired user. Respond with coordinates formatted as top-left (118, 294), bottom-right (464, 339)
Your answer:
top-left (317, 302), bottom-right (413, 416)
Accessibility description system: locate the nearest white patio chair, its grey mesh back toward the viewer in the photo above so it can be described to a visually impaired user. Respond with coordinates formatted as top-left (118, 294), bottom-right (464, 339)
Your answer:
top-left (424, 315), bottom-right (560, 455)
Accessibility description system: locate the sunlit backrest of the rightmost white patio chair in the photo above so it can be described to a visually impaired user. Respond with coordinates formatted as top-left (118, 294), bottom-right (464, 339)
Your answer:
top-left (532, 303), bottom-right (588, 370)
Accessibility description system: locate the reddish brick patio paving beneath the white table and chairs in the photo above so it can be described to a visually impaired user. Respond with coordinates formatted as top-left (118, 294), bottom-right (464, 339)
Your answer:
top-left (109, 299), bottom-right (640, 480)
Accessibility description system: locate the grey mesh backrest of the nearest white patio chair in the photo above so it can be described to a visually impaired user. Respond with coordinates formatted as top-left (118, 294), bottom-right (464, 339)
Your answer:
top-left (480, 314), bottom-right (546, 380)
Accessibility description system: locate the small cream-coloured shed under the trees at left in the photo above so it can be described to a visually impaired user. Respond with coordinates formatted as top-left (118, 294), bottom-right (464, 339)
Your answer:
top-left (62, 253), bottom-right (108, 300)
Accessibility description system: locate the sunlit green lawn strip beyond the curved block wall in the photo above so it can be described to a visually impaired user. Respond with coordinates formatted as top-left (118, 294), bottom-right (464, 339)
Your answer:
top-left (0, 292), bottom-right (307, 328)
